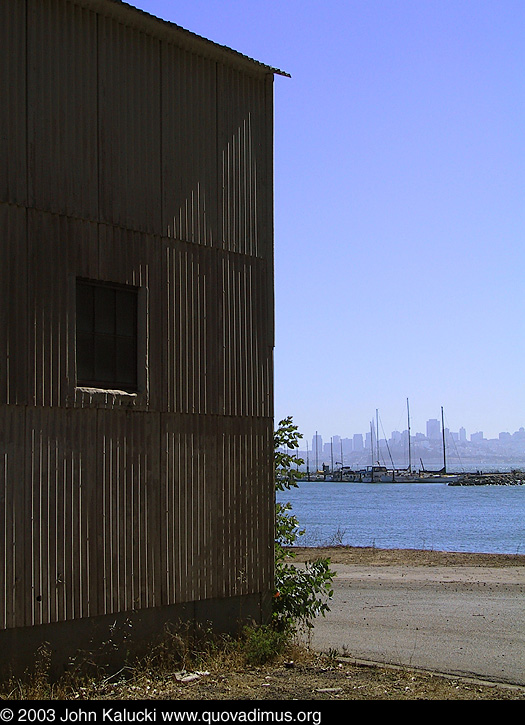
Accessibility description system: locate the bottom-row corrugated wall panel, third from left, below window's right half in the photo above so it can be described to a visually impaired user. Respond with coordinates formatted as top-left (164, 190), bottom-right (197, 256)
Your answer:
top-left (98, 410), bottom-right (160, 613)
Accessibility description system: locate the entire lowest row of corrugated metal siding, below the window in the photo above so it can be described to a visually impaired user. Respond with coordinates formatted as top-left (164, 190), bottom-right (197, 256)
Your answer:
top-left (0, 406), bottom-right (273, 628)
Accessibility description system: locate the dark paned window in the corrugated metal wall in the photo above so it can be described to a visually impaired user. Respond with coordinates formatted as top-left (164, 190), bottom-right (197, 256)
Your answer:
top-left (76, 280), bottom-right (138, 392)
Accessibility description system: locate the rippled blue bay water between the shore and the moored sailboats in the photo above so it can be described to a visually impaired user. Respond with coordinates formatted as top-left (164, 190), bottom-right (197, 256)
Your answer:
top-left (277, 481), bottom-right (525, 554)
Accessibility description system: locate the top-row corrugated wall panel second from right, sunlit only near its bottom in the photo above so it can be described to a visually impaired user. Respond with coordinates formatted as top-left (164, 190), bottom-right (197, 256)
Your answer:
top-left (162, 42), bottom-right (218, 245)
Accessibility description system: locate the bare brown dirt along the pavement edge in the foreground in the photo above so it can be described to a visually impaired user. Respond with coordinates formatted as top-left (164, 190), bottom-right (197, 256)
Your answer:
top-left (84, 651), bottom-right (525, 701)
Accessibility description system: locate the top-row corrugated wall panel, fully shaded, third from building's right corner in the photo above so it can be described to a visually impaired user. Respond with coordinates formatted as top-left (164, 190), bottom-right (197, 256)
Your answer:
top-left (98, 15), bottom-right (162, 234)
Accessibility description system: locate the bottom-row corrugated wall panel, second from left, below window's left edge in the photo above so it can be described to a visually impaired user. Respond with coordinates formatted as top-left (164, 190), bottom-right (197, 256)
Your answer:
top-left (21, 407), bottom-right (96, 626)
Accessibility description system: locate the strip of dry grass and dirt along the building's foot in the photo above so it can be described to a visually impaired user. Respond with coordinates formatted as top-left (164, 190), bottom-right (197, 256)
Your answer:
top-left (0, 624), bottom-right (525, 701)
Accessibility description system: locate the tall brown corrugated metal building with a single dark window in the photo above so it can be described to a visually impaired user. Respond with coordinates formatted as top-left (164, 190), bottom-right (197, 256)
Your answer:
top-left (0, 0), bottom-right (286, 680)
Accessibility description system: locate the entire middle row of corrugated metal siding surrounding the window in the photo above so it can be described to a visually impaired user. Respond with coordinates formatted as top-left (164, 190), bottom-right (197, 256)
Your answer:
top-left (6, 205), bottom-right (272, 417)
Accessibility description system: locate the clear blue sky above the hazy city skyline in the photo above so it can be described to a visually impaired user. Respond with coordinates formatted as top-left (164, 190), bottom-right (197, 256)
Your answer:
top-left (132, 0), bottom-right (525, 440)
